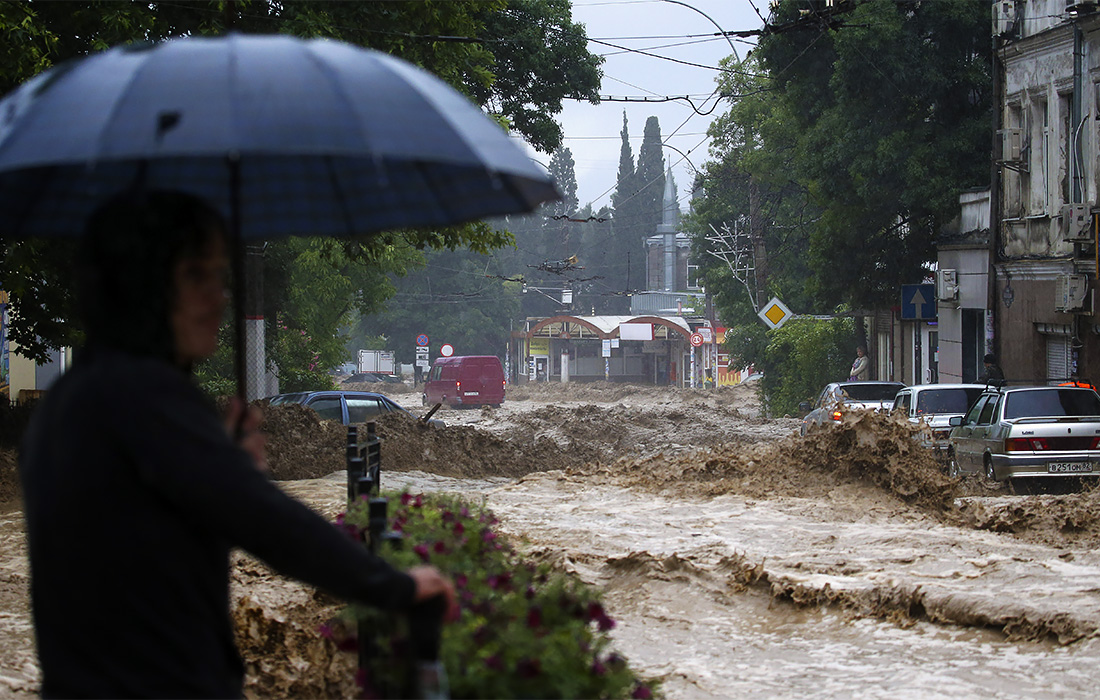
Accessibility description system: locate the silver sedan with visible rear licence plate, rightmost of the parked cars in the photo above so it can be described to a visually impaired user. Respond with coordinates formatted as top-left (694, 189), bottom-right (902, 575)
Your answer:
top-left (948, 386), bottom-right (1100, 481)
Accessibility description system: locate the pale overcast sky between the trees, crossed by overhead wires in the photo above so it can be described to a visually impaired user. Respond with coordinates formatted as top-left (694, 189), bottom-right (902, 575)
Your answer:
top-left (550, 0), bottom-right (769, 209)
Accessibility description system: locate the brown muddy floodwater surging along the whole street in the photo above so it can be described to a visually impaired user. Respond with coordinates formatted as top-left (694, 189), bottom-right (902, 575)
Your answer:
top-left (0, 385), bottom-right (1100, 699)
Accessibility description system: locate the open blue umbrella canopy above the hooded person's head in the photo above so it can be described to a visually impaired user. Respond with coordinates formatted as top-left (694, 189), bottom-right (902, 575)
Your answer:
top-left (0, 34), bottom-right (559, 238)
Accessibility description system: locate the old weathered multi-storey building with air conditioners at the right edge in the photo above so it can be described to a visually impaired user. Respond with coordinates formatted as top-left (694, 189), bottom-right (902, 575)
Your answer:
top-left (990, 0), bottom-right (1100, 381)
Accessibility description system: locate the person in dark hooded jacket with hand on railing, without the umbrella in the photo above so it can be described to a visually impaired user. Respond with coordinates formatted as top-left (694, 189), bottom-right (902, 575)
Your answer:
top-left (19, 192), bottom-right (457, 698)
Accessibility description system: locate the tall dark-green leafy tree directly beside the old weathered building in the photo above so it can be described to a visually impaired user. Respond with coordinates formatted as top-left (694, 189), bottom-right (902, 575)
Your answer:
top-left (757, 0), bottom-right (992, 308)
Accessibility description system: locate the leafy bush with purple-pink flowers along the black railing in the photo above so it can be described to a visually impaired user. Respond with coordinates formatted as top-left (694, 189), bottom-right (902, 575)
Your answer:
top-left (338, 493), bottom-right (653, 698)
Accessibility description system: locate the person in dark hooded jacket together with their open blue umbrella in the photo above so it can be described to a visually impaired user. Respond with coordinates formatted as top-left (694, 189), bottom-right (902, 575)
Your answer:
top-left (0, 33), bottom-right (561, 697)
